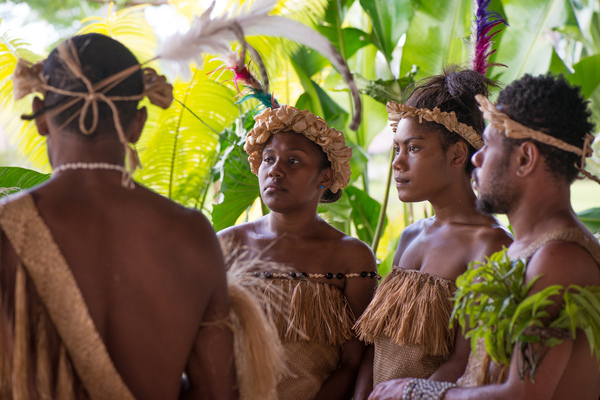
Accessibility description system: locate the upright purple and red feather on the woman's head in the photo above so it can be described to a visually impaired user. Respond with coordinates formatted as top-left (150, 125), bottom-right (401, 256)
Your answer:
top-left (471, 0), bottom-right (508, 75)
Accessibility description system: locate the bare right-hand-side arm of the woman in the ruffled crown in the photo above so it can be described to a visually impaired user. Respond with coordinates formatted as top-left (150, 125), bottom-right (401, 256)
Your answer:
top-left (315, 243), bottom-right (377, 400)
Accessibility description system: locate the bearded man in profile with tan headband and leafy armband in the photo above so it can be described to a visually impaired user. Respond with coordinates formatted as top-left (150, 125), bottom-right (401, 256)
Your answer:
top-left (371, 75), bottom-right (600, 400)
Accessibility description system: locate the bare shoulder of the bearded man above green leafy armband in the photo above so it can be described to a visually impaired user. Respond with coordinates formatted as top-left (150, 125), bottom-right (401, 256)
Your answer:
top-left (526, 240), bottom-right (600, 287)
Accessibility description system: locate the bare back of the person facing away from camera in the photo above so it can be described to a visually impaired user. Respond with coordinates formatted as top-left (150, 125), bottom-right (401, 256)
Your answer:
top-left (11, 171), bottom-right (235, 399)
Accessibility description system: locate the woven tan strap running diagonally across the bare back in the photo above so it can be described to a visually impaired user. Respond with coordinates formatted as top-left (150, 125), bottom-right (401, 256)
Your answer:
top-left (0, 194), bottom-right (134, 400)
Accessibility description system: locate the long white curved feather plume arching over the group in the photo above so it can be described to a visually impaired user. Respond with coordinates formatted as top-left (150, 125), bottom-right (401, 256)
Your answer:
top-left (159, 0), bottom-right (362, 130)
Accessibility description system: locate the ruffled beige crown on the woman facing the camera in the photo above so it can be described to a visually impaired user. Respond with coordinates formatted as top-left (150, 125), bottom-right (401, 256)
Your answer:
top-left (244, 104), bottom-right (352, 193)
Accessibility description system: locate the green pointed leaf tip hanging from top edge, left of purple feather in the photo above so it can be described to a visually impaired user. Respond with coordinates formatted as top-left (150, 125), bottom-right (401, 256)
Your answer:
top-left (360, 0), bottom-right (413, 63)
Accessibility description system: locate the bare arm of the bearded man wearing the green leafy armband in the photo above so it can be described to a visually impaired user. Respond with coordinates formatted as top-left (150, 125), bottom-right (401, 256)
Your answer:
top-left (370, 242), bottom-right (599, 400)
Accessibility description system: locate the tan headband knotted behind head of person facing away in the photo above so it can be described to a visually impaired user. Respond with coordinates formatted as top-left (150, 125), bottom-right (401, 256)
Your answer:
top-left (12, 39), bottom-right (173, 188)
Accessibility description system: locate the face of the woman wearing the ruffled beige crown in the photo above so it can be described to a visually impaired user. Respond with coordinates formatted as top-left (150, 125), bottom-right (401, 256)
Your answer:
top-left (258, 132), bottom-right (332, 213)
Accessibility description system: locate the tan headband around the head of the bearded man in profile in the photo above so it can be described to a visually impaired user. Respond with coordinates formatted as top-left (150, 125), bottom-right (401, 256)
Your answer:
top-left (475, 94), bottom-right (600, 183)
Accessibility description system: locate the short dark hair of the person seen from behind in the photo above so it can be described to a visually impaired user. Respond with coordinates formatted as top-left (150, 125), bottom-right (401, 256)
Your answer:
top-left (44, 33), bottom-right (144, 136)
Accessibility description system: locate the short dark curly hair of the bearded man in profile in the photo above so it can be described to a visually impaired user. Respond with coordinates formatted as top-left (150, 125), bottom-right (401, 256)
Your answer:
top-left (498, 74), bottom-right (594, 183)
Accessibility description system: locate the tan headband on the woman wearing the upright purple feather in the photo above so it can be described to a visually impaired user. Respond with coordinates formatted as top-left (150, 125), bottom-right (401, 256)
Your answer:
top-left (385, 101), bottom-right (483, 150)
